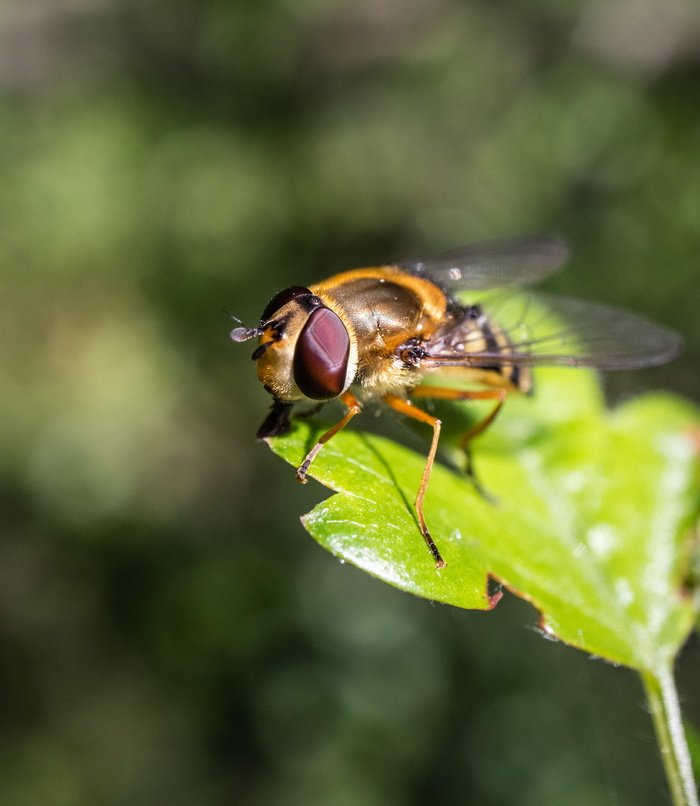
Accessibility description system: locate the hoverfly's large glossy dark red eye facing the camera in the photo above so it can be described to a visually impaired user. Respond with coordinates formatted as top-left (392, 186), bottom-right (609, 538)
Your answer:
top-left (294, 308), bottom-right (350, 400)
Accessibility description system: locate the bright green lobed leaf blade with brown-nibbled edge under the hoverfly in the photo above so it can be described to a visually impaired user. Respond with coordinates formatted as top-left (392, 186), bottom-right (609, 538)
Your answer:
top-left (270, 369), bottom-right (700, 669)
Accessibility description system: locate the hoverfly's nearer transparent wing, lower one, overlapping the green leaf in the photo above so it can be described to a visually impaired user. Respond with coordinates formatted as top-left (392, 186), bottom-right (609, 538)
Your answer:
top-left (424, 293), bottom-right (683, 369)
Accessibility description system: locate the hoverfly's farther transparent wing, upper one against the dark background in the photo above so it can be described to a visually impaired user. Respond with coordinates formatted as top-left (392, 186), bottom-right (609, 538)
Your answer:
top-left (395, 235), bottom-right (569, 291)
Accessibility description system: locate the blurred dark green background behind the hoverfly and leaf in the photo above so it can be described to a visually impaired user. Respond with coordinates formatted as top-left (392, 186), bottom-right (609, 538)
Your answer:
top-left (0, 0), bottom-right (700, 806)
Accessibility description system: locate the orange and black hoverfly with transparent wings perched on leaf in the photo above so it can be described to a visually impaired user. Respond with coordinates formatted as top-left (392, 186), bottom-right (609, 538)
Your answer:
top-left (231, 235), bottom-right (682, 568)
